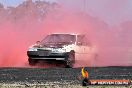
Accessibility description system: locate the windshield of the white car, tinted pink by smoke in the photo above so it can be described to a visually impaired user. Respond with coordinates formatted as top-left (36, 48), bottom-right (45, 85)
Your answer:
top-left (41, 34), bottom-right (75, 44)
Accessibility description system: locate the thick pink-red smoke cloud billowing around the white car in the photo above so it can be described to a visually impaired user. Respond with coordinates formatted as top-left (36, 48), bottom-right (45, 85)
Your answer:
top-left (0, 2), bottom-right (132, 67)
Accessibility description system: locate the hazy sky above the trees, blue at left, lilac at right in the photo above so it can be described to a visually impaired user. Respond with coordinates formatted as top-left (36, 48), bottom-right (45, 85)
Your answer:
top-left (0, 0), bottom-right (132, 25)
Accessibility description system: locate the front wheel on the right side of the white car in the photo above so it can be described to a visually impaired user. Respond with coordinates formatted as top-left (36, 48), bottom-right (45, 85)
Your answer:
top-left (65, 51), bottom-right (75, 68)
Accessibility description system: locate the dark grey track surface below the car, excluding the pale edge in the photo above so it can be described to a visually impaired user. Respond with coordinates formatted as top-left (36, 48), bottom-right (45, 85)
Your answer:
top-left (0, 67), bottom-right (132, 84)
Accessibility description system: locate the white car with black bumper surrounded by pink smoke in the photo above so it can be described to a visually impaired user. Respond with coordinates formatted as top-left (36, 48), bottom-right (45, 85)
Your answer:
top-left (27, 33), bottom-right (97, 67)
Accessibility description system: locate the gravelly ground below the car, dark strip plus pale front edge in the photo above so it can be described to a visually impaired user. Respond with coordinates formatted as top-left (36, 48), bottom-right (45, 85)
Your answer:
top-left (0, 67), bottom-right (132, 88)
